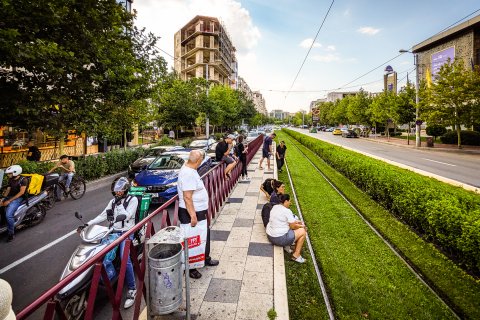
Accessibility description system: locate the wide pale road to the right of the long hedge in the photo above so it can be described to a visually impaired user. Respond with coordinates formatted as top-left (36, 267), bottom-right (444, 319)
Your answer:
top-left (287, 129), bottom-right (480, 187)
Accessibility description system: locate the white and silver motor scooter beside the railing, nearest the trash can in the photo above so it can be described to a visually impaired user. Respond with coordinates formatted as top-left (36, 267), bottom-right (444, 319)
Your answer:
top-left (56, 212), bottom-right (143, 320)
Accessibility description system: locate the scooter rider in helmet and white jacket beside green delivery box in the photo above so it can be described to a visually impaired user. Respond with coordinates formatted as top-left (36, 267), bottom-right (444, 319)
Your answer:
top-left (79, 177), bottom-right (138, 309)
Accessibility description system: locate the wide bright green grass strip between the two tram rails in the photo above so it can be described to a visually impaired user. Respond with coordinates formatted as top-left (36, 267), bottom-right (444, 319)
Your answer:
top-left (279, 134), bottom-right (454, 319)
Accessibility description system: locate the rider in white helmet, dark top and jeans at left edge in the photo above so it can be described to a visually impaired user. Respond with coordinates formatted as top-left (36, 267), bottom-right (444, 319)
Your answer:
top-left (0, 165), bottom-right (28, 242)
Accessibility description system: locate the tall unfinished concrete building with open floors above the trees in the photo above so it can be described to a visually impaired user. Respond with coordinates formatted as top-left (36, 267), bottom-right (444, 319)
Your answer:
top-left (174, 16), bottom-right (238, 89)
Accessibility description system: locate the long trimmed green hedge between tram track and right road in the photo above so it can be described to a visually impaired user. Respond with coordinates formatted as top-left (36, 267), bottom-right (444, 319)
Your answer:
top-left (284, 129), bottom-right (480, 274)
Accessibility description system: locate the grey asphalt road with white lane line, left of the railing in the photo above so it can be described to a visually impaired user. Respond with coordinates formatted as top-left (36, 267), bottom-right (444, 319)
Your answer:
top-left (0, 178), bottom-right (169, 319)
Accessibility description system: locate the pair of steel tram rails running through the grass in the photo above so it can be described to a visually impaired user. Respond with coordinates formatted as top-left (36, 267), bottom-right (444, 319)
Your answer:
top-left (285, 137), bottom-right (462, 319)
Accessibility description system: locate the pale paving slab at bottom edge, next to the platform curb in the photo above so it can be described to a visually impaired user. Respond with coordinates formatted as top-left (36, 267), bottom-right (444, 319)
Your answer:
top-left (235, 292), bottom-right (273, 320)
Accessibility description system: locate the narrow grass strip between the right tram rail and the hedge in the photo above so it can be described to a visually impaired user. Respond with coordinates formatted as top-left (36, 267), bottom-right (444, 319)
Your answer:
top-left (280, 133), bottom-right (480, 319)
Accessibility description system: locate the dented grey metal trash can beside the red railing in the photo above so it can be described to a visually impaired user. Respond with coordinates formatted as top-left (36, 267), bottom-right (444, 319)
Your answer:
top-left (148, 243), bottom-right (183, 316)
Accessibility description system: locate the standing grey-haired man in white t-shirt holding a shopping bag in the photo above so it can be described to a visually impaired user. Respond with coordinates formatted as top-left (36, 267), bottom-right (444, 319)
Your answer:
top-left (177, 150), bottom-right (218, 279)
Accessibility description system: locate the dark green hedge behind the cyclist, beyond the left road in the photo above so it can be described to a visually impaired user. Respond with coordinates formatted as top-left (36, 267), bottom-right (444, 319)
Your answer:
top-left (19, 148), bottom-right (147, 181)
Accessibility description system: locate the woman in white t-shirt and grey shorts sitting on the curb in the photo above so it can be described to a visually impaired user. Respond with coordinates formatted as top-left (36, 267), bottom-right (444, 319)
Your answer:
top-left (266, 194), bottom-right (307, 263)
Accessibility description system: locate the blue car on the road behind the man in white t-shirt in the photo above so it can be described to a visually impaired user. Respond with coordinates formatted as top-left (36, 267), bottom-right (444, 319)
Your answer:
top-left (133, 149), bottom-right (212, 204)
